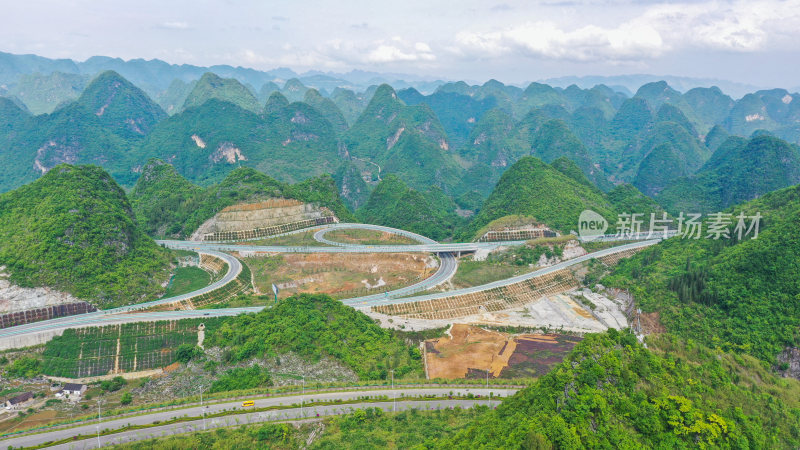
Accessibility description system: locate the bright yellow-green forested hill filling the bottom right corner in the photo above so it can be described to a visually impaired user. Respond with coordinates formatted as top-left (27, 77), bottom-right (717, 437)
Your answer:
top-left (444, 329), bottom-right (800, 449)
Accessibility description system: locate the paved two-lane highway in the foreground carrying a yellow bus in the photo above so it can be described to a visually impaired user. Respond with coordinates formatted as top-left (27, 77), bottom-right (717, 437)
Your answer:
top-left (0, 387), bottom-right (517, 448)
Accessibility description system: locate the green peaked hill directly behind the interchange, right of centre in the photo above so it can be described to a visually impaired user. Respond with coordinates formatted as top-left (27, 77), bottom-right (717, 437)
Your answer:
top-left (464, 156), bottom-right (616, 238)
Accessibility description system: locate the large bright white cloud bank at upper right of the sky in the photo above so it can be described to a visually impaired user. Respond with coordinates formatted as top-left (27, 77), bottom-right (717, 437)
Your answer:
top-left (451, 0), bottom-right (800, 63)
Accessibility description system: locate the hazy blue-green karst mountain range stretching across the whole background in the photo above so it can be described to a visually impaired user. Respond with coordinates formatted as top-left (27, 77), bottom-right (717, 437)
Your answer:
top-left (0, 54), bottom-right (800, 244)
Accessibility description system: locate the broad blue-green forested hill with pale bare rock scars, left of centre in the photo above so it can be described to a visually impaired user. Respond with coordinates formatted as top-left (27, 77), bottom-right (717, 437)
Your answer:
top-left (136, 97), bottom-right (342, 185)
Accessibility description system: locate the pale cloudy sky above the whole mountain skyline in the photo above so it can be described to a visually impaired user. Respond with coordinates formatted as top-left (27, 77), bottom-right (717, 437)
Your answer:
top-left (0, 0), bottom-right (800, 88)
